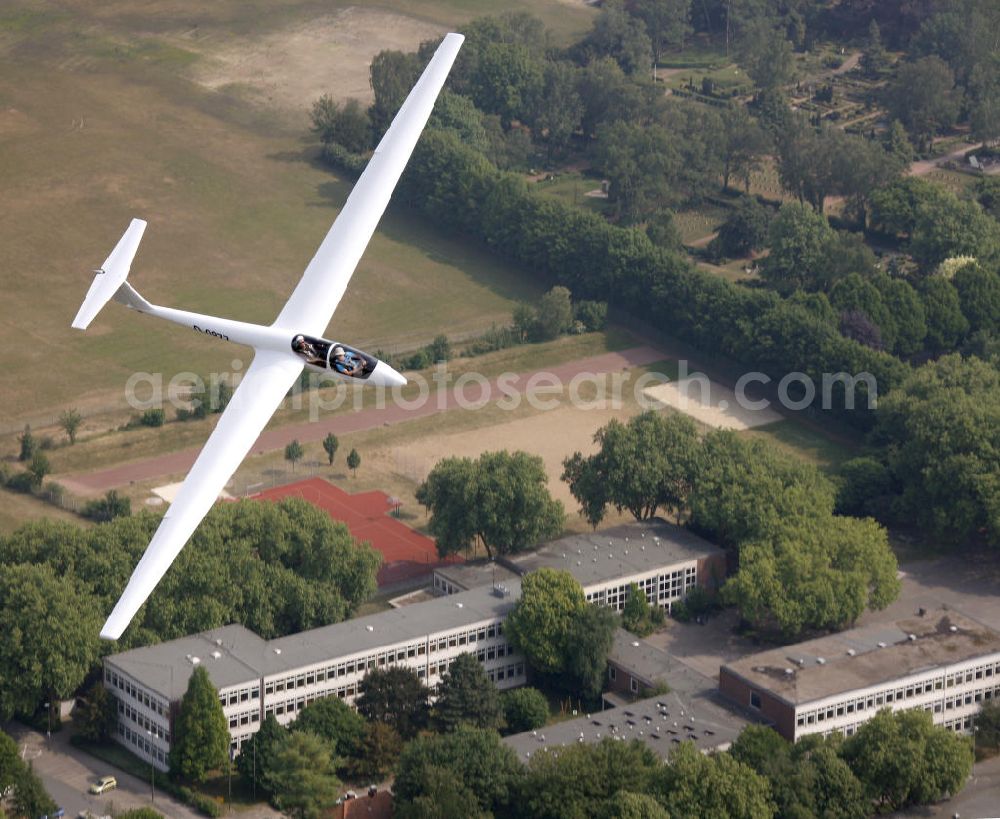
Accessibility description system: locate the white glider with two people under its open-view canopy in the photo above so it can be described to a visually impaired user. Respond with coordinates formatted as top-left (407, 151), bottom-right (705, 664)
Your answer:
top-left (73, 34), bottom-right (465, 640)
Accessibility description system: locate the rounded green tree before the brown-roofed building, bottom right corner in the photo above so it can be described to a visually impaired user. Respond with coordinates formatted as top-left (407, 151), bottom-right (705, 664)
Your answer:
top-left (843, 708), bottom-right (973, 810)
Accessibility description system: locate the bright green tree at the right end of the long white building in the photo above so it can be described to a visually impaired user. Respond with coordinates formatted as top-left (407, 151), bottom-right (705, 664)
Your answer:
top-left (504, 569), bottom-right (587, 674)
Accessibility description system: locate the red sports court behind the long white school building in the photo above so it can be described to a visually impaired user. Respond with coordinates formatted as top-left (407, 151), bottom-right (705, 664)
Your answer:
top-left (252, 478), bottom-right (462, 586)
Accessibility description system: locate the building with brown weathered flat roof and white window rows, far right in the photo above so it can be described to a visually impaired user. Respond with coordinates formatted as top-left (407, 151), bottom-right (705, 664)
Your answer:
top-left (719, 609), bottom-right (1000, 741)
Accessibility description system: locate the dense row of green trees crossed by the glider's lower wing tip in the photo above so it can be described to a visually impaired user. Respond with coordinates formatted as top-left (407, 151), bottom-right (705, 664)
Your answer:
top-left (0, 499), bottom-right (380, 719)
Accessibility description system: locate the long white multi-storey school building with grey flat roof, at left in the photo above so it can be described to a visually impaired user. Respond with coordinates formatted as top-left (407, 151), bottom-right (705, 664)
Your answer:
top-left (104, 581), bottom-right (525, 770)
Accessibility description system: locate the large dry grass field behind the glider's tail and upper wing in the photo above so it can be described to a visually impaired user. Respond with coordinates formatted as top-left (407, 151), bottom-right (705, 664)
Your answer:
top-left (0, 0), bottom-right (592, 430)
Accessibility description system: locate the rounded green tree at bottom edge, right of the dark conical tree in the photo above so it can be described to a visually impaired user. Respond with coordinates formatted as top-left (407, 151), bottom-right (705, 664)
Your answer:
top-left (264, 732), bottom-right (340, 819)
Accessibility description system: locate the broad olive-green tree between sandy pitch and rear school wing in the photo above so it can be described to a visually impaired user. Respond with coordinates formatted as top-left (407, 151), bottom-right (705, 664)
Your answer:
top-left (562, 411), bottom-right (698, 526)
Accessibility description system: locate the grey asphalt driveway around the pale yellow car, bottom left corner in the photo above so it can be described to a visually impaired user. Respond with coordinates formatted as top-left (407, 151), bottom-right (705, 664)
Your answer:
top-left (4, 722), bottom-right (281, 819)
